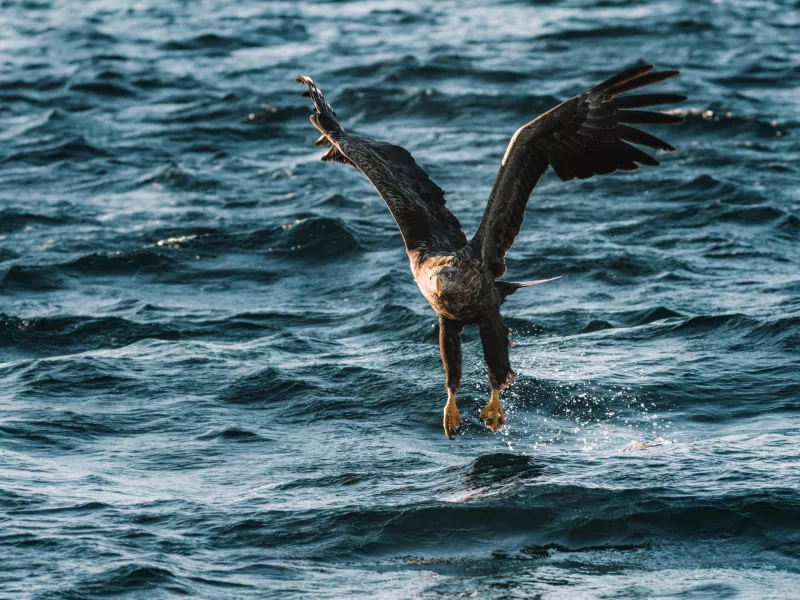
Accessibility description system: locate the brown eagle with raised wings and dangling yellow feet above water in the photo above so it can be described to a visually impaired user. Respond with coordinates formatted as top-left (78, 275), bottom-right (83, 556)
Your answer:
top-left (297, 64), bottom-right (686, 439)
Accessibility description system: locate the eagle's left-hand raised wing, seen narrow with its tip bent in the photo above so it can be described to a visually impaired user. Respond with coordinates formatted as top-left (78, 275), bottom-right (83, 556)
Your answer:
top-left (297, 75), bottom-right (467, 255)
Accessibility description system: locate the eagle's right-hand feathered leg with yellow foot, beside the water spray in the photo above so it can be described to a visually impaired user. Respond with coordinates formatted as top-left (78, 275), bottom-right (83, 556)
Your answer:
top-left (481, 312), bottom-right (514, 433)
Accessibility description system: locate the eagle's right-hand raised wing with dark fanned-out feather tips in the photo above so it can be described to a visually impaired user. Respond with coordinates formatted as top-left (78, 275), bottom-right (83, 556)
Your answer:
top-left (472, 65), bottom-right (686, 277)
